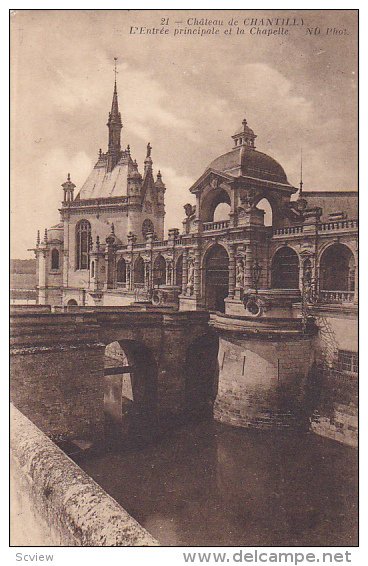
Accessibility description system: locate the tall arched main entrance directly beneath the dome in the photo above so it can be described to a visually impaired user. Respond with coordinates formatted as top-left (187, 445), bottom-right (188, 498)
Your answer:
top-left (204, 244), bottom-right (229, 312)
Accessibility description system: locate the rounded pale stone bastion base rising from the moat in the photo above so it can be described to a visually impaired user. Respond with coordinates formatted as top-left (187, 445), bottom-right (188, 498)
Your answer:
top-left (214, 335), bottom-right (313, 428)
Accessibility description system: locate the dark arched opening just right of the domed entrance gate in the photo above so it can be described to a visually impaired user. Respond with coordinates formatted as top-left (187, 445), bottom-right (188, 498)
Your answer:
top-left (271, 247), bottom-right (299, 289)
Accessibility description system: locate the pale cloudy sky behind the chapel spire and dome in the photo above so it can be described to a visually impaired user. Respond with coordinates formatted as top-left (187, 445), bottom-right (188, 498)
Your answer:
top-left (11, 10), bottom-right (358, 259)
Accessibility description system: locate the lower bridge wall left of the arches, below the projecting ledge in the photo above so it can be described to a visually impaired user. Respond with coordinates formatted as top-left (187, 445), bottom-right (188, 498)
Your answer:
top-left (10, 345), bottom-right (104, 440)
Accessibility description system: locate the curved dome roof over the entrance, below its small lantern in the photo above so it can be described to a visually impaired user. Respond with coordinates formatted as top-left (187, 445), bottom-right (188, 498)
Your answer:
top-left (209, 145), bottom-right (289, 185)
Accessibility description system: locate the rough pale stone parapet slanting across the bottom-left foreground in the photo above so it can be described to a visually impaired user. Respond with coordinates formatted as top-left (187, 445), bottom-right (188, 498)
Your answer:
top-left (11, 407), bottom-right (158, 546)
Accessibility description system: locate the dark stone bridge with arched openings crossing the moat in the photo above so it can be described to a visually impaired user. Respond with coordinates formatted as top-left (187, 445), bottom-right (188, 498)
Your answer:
top-left (11, 307), bottom-right (218, 440)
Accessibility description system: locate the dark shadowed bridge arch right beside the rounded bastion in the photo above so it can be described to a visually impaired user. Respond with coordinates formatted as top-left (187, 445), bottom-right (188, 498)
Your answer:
top-left (184, 333), bottom-right (219, 418)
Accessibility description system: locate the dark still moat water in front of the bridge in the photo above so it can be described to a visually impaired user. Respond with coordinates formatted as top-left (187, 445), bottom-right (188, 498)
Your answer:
top-left (80, 421), bottom-right (357, 546)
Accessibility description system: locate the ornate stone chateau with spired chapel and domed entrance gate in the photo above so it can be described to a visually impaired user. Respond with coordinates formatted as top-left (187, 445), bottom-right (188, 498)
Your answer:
top-left (30, 73), bottom-right (358, 444)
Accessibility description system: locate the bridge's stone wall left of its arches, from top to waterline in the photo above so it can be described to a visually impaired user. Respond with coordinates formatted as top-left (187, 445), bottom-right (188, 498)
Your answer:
top-left (10, 311), bottom-right (104, 440)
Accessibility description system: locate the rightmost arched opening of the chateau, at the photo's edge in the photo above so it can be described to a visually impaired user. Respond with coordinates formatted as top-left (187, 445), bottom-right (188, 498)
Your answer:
top-left (320, 244), bottom-right (355, 292)
